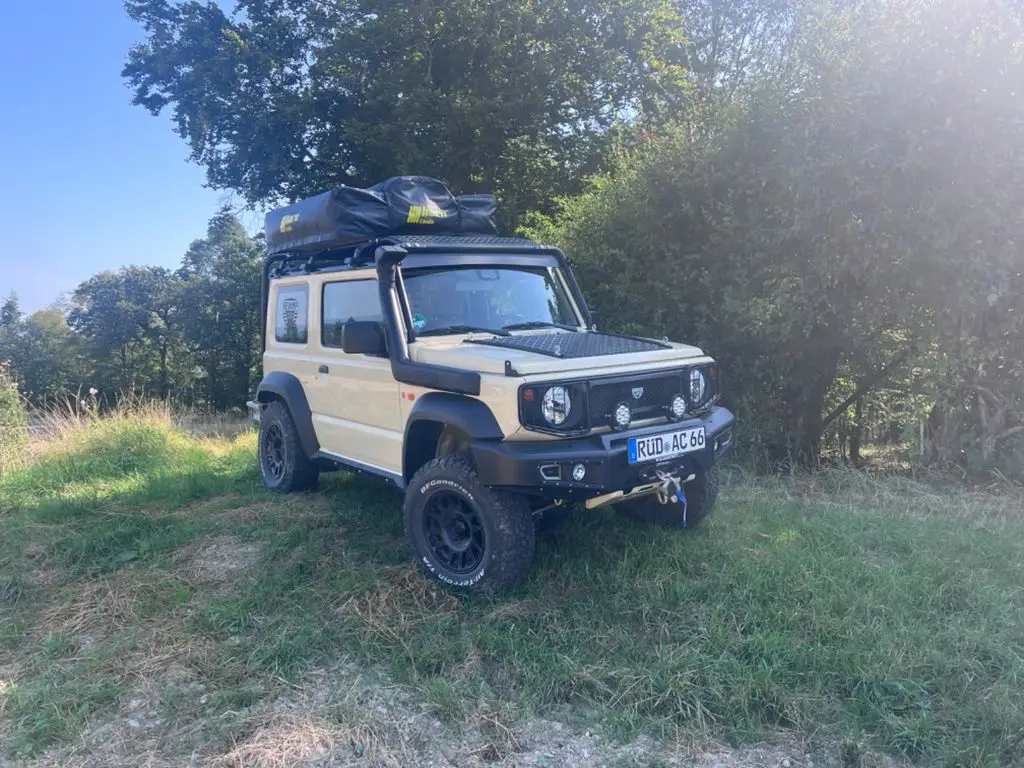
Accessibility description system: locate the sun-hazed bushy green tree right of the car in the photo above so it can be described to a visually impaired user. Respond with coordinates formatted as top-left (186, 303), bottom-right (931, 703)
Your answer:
top-left (545, 0), bottom-right (1024, 464)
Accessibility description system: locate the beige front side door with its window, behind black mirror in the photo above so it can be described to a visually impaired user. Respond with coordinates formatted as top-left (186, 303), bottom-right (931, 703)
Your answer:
top-left (307, 275), bottom-right (402, 475)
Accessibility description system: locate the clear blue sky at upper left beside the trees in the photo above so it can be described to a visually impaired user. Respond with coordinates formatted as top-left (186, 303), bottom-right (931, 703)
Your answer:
top-left (0, 0), bottom-right (261, 311)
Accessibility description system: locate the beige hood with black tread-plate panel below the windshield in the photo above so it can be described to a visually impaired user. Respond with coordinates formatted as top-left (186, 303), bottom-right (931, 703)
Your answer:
top-left (409, 331), bottom-right (705, 376)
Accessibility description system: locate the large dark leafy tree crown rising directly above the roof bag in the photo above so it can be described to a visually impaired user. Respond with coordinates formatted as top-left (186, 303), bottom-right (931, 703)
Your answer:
top-left (123, 0), bottom-right (685, 227)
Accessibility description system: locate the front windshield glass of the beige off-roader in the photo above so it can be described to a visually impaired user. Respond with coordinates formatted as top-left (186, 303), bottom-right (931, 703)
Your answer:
top-left (402, 266), bottom-right (579, 334)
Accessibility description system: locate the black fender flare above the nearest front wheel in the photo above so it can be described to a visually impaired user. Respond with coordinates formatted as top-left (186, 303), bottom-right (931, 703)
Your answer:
top-left (402, 392), bottom-right (505, 483)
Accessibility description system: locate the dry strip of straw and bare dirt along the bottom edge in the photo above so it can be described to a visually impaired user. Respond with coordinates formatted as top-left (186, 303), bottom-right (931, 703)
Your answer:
top-left (16, 663), bottom-right (905, 768)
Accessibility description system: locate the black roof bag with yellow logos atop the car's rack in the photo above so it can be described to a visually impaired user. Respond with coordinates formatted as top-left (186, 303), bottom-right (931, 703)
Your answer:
top-left (265, 176), bottom-right (498, 255)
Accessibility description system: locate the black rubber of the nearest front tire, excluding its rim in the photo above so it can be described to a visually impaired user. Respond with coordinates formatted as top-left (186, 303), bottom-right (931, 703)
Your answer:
top-left (403, 453), bottom-right (537, 594)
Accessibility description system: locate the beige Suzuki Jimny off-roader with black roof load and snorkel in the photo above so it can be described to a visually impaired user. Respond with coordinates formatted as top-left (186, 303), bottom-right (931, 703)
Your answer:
top-left (250, 176), bottom-right (733, 592)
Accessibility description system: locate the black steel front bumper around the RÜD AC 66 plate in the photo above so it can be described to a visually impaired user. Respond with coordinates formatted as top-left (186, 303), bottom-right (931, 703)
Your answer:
top-left (470, 406), bottom-right (735, 500)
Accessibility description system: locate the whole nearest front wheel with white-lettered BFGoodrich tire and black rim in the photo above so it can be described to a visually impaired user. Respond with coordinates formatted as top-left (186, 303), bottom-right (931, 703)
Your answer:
top-left (404, 454), bottom-right (536, 594)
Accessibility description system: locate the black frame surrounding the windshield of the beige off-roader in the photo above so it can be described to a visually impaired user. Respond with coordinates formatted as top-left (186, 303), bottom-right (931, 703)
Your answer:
top-left (396, 254), bottom-right (587, 343)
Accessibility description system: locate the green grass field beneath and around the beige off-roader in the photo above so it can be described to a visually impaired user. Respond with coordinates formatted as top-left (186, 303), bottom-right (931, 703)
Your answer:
top-left (0, 412), bottom-right (1024, 766)
